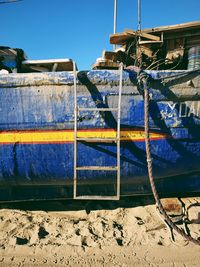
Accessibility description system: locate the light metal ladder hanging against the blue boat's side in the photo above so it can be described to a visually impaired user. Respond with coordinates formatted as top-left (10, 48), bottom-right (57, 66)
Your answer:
top-left (73, 62), bottom-right (123, 200)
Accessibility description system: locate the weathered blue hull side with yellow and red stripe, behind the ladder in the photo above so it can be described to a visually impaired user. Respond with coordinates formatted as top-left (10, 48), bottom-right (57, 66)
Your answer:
top-left (0, 71), bottom-right (200, 201)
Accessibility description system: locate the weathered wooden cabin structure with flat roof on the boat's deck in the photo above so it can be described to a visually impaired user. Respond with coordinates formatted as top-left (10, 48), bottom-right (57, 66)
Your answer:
top-left (93, 21), bottom-right (200, 70)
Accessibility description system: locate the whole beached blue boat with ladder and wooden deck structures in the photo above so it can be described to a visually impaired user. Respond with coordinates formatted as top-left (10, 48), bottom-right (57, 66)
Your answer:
top-left (0, 22), bottom-right (200, 202)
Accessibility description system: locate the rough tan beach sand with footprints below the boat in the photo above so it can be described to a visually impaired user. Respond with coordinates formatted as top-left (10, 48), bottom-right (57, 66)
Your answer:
top-left (0, 197), bottom-right (200, 267)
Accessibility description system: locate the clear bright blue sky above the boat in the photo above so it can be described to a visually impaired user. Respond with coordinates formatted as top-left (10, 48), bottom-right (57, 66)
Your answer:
top-left (0, 0), bottom-right (200, 70)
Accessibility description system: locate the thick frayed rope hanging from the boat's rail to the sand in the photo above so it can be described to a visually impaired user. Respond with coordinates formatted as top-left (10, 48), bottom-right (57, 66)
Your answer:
top-left (138, 72), bottom-right (200, 246)
